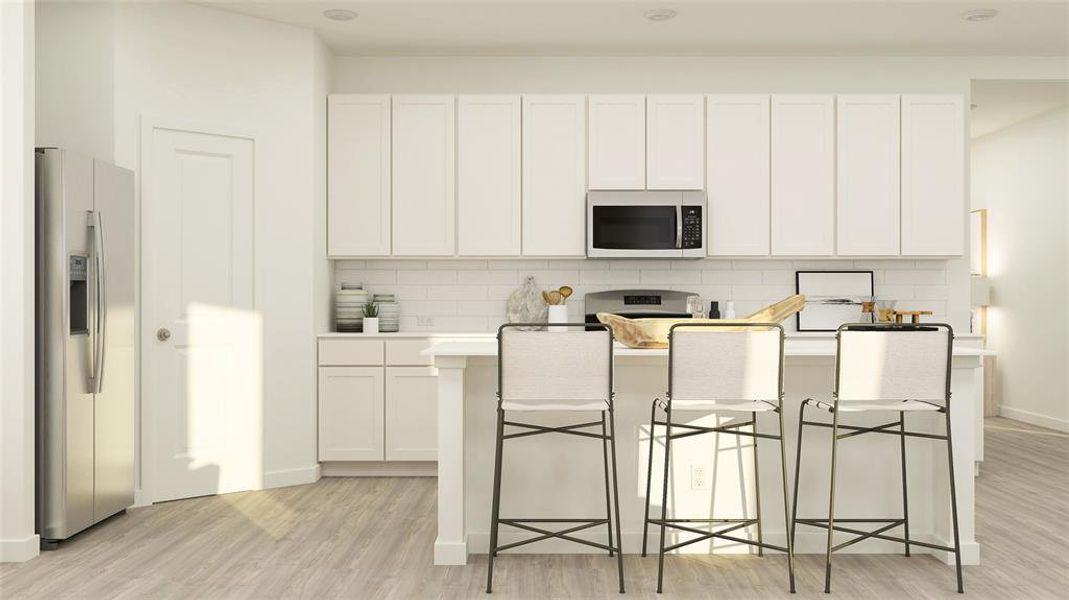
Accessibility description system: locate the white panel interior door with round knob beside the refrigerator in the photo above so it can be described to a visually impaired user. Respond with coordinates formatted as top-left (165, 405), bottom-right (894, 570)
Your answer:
top-left (141, 125), bottom-right (262, 502)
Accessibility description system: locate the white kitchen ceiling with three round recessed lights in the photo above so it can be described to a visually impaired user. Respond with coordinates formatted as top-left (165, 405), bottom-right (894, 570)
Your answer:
top-left (188, 0), bottom-right (1069, 56)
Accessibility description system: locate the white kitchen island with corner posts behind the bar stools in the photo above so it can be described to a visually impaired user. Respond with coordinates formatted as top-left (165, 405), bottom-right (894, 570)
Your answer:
top-left (424, 335), bottom-right (987, 565)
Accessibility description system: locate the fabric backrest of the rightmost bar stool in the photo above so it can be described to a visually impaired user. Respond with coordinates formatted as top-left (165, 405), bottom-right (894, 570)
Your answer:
top-left (835, 323), bottom-right (954, 402)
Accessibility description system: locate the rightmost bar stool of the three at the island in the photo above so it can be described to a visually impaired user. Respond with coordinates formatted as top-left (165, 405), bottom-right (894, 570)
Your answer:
top-left (791, 323), bottom-right (964, 594)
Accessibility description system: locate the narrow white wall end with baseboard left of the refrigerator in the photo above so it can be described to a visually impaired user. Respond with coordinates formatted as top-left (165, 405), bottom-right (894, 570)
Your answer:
top-left (0, 2), bottom-right (40, 563)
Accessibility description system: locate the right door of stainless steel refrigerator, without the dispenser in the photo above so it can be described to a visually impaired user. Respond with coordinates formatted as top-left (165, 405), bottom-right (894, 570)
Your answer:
top-left (93, 160), bottom-right (137, 520)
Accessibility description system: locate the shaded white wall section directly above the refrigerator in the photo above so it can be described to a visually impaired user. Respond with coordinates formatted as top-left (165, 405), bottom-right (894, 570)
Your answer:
top-left (36, 2), bottom-right (115, 161)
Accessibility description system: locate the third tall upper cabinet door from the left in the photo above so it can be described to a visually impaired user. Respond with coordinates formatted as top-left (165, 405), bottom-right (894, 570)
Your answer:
top-left (456, 95), bottom-right (520, 257)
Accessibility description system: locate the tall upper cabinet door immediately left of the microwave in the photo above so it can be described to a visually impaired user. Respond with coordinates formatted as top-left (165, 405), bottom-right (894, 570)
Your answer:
top-left (523, 95), bottom-right (587, 257)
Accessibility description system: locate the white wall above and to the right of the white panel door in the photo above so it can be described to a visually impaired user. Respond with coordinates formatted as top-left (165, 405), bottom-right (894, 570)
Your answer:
top-left (114, 2), bottom-right (323, 487)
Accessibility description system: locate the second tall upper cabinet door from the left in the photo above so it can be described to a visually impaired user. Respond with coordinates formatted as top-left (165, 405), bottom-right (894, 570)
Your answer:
top-left (393, 95), bottom-right (456, 256)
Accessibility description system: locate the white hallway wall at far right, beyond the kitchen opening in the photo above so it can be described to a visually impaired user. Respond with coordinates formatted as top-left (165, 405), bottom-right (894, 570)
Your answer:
top-left (972, 108), bottom-right (1069, 431)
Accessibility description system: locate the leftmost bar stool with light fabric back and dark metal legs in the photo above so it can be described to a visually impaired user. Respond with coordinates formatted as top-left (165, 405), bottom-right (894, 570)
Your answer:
top-left (486, 323), bottom-right (623, 594)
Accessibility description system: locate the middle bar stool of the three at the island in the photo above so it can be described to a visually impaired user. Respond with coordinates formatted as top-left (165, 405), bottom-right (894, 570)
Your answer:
top-left (642, 323), bottom-right (794, 594)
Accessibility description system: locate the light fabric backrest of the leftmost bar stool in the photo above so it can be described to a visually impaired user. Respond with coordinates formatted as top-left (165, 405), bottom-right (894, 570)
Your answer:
top-left (497, 323), bottom-right (613, 404)
